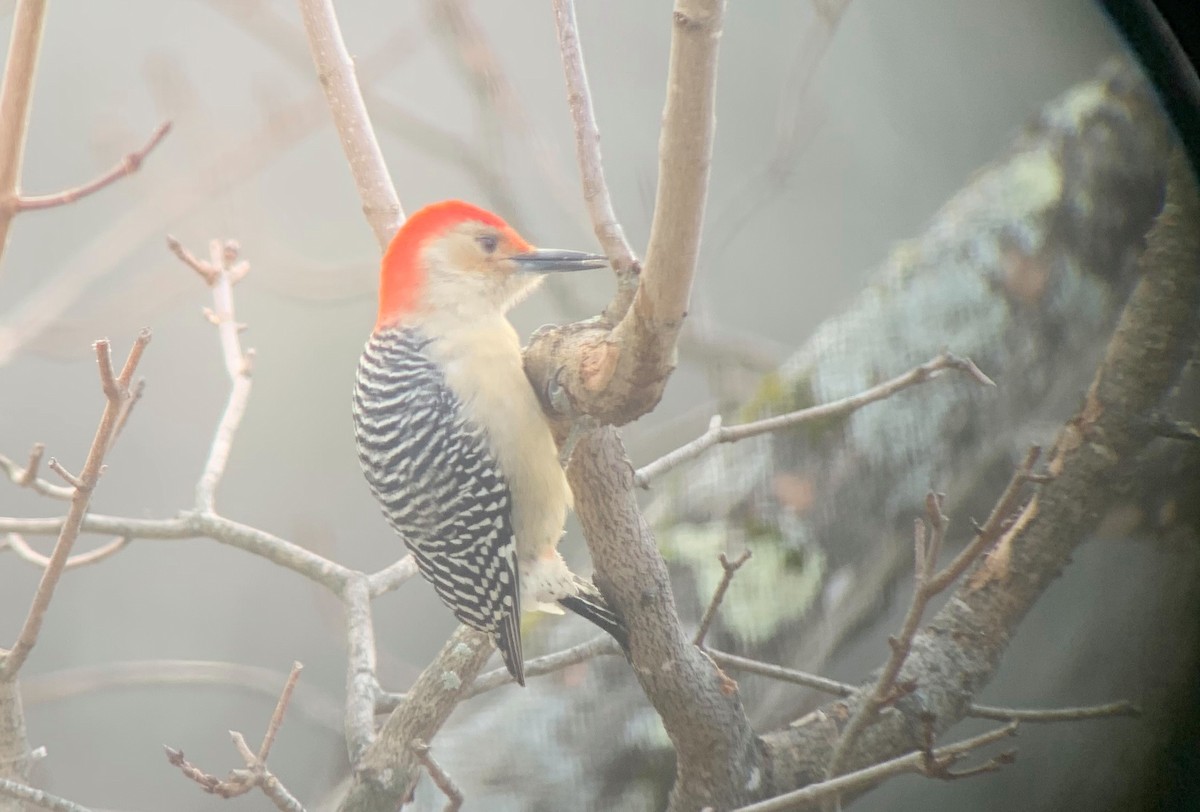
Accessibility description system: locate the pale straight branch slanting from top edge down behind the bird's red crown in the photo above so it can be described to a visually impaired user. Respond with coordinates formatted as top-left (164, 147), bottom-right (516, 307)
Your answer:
top-left (299, 0), bottom-right (404, 251)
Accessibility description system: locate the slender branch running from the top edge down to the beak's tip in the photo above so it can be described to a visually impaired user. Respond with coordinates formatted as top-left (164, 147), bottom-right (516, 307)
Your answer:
top-left (553, 0), bottom-right (640, 281)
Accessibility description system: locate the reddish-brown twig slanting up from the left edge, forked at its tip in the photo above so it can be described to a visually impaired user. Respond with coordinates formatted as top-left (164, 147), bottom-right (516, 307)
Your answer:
top-left (0, 330), bottom-right (150, 680)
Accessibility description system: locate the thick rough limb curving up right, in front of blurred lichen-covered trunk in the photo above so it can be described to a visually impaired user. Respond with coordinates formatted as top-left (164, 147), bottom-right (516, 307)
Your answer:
top-left (763, 153), bottom-right (1200, 806)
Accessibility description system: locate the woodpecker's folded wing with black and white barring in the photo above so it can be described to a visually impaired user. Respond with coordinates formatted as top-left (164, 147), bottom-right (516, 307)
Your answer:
top-left (354, 330), bottom-right (524, 685)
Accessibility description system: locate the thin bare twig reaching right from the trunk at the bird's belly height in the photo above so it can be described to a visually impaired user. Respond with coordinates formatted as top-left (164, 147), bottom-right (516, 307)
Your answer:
top-left (636, 353), bottom-right (995, 488)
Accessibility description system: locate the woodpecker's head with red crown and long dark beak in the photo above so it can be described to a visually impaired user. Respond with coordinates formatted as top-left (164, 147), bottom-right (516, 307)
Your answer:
top-left (376, 200), bottom-right (607, 330)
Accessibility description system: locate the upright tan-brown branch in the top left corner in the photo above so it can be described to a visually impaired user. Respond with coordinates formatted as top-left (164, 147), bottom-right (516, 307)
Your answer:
top-left (0, 0), bottom-right (46, 272)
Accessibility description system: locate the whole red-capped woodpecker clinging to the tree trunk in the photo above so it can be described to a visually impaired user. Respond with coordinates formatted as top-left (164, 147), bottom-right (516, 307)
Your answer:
top-left (354, 200), bottom-right (625, 685)
